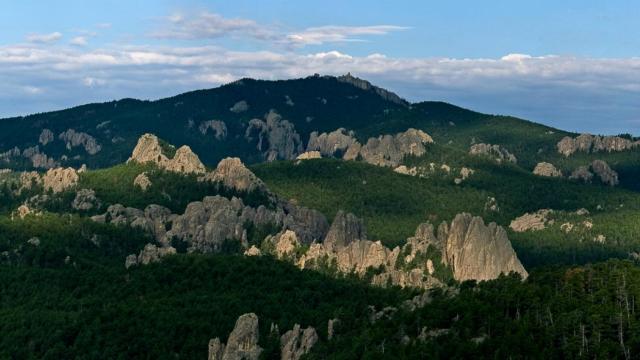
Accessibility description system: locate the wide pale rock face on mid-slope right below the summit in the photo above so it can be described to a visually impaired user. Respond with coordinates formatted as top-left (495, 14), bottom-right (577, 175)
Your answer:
top-left (307, 128), bottom-right (433, 167)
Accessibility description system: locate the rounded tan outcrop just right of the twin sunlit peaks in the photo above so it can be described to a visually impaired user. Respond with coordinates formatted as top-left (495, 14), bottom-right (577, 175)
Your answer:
top-left (201, 158), bottom-right (266, 192)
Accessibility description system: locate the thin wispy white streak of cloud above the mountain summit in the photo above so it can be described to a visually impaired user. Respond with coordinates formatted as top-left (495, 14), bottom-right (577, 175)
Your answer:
top-left (287, 25), bottom-right (408, 46)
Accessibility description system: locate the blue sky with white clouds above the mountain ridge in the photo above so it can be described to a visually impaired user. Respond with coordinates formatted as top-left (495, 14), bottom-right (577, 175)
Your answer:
top-left (0, 0), bottom-right (640, 135)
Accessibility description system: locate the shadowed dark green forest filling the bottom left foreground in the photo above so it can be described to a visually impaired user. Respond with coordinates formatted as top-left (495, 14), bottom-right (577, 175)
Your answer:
top-left (0, 255), bottom-right (407, 359)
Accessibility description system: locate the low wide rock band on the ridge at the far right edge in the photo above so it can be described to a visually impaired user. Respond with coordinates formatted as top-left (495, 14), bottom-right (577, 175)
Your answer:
top-left (556, 134), bottom-right (640, 156)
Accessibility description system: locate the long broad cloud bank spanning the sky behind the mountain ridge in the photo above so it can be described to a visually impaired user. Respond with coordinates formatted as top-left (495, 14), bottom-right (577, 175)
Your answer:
top-left (0, 40), bottom-right (640, 133)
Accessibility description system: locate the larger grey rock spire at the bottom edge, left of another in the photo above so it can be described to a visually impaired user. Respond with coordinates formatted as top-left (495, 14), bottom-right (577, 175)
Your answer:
top-left (209, 313), bottom-right (262, 360)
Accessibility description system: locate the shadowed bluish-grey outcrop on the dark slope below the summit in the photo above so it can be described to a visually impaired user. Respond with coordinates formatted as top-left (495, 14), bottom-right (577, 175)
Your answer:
top-left (245, 111), bottom-right (303, 161)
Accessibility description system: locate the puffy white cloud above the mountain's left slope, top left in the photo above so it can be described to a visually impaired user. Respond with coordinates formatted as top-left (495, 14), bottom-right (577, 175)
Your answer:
top-left (153, 11), bottom-right (276, 40)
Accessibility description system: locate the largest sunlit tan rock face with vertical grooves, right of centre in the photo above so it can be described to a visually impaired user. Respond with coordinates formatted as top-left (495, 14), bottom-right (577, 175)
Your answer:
top-left (443, 214), bottom-right (528, 281)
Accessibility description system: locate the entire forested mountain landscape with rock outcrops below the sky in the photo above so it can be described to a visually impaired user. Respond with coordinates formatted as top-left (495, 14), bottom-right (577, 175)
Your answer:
top-left (0, 74), bottom-right (640, 359)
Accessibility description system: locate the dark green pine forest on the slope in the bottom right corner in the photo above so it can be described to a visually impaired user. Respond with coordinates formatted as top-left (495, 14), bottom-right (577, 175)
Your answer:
top-left (311, 260), bottom-right (640, 359)
